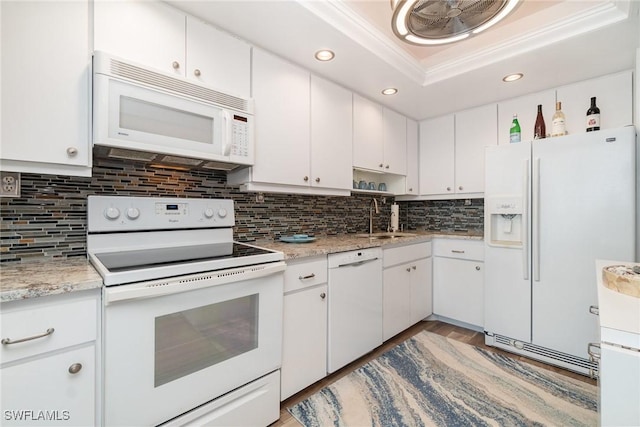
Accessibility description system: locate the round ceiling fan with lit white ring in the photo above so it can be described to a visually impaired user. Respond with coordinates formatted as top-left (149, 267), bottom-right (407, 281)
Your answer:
top-left (391, 0), bottom-right (519, 45)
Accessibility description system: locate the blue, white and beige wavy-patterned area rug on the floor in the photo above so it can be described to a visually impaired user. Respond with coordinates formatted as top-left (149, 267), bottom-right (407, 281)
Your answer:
top-left (288, 331), bottom-right (598, 427)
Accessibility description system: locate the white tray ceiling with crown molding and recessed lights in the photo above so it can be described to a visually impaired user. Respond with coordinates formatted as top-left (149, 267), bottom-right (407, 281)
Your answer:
top-left (168, 0), bottom-right (640, 120)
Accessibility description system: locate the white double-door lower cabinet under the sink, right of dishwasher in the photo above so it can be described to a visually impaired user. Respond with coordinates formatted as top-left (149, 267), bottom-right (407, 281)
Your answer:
top-left (382, 242), bottom-right (432, 341)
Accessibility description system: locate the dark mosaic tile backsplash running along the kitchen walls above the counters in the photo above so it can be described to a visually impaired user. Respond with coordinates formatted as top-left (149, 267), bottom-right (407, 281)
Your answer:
top-left (0, 159), bottom-right (483, 262)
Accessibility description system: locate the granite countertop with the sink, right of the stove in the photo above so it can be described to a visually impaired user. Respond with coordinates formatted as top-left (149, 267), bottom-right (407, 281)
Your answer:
top-left (248, 231), bottom-right (484, 260)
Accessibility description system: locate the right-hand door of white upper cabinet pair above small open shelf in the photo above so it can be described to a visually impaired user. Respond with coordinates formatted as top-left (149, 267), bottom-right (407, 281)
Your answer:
top-left (382, 108), bottom-right (407, 175)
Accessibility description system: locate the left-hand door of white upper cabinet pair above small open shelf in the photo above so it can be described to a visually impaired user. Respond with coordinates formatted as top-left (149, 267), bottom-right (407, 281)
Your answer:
top-left (353, 94), bottom-right (384, 170)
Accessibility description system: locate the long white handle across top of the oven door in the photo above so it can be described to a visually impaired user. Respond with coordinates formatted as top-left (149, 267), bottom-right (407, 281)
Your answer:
top-left (103, 261), bottom-right (287, 305)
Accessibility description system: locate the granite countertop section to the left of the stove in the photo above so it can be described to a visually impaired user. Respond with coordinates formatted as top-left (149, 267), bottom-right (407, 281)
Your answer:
top-left (0, 258), bottom-right (102, 302)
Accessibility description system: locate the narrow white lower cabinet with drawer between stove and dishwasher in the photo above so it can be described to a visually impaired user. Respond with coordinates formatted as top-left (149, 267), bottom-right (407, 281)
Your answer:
top-left (280, 256), bottom-right (327, 400)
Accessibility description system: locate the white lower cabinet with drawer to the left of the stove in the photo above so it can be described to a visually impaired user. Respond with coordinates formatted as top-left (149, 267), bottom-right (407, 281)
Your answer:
top-left (0, 291), bottom-right (99, 426)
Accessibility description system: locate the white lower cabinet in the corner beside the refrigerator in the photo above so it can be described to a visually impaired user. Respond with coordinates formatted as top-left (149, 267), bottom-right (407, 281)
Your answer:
top-left (433, 239), bottom-right (484, 329)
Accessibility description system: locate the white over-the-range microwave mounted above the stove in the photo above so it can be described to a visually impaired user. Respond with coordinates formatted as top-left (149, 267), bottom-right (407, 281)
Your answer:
top-left (93, 52), bottom-right (254, 170)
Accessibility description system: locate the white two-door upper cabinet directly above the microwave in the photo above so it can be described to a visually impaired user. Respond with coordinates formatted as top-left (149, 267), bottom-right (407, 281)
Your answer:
top-left (94, 1), bottom-right (251, 98)
